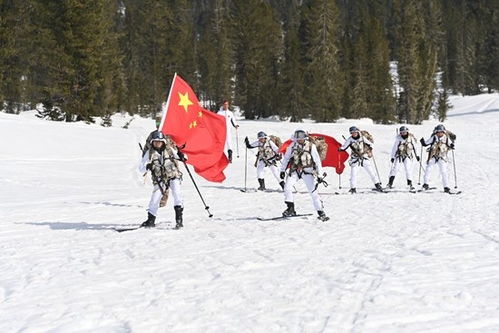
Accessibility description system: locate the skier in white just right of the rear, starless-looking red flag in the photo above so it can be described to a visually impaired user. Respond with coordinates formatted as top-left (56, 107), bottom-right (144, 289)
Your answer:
top-left (338, 126), bottom-right (383, 194)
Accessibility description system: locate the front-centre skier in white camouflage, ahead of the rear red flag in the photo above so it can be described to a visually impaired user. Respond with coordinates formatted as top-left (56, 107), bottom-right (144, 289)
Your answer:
top-left (280, 130), bottom-right (329, 221)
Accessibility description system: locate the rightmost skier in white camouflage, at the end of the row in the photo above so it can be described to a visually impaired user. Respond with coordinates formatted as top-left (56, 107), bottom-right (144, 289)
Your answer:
top-left (421, 124), bottom-right (456, 193)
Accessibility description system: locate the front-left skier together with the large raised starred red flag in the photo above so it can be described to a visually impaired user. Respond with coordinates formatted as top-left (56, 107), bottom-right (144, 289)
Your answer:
top-left (131, 74), bottom-right (229, 231)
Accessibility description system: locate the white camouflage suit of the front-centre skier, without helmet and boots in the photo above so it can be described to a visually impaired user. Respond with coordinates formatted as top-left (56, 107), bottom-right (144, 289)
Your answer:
top-left (281, 139), bottom-right (324, 211)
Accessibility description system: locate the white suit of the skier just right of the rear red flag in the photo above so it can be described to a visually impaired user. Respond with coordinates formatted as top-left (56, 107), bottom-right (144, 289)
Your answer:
top-left (340, 133), bottom-right (380, 188)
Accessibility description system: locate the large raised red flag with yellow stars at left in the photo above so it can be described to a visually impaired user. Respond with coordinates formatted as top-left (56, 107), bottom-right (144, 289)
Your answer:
top-left (160, 74), bottom-right (229, 182)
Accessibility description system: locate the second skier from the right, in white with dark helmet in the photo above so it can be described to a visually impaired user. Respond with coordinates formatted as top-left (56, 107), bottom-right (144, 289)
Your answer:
top-left (387, 126), bottom-right (420, 191)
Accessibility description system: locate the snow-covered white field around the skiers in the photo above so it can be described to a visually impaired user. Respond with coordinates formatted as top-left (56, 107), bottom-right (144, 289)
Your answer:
top-left (0, 94), bottom-right (499, 333)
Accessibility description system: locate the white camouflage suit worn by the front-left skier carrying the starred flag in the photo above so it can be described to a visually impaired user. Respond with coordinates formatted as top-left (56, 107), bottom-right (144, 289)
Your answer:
top-left (139, 145), bottom-right (183, 216)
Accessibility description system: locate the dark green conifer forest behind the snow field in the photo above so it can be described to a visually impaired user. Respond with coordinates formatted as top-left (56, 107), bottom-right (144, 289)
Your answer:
top-left (0, 0), bottom-right (499, 124)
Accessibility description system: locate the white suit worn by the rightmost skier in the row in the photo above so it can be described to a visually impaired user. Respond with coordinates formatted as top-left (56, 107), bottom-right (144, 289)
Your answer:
top-left (424, 134), bottom-right (451, 187)
